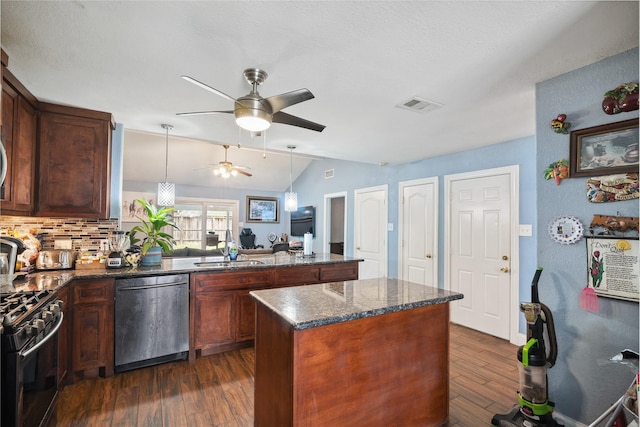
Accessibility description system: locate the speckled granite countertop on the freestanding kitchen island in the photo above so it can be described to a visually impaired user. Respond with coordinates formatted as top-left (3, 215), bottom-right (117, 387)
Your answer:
top-left (250, 278), bottom-right (464, 330)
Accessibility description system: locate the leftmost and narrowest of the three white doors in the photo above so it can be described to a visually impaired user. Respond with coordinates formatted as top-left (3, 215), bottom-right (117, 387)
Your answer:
top-left (353, 185), bottom-right (387, 279)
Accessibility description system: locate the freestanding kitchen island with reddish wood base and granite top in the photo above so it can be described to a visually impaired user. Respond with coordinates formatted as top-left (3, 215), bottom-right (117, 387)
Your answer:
top-left (250, 278), bottom-right (463, 427)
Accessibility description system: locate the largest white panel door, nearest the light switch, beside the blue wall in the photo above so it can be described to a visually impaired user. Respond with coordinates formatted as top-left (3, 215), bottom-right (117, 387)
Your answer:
top-left (445, 168), bottom-right (518, 339)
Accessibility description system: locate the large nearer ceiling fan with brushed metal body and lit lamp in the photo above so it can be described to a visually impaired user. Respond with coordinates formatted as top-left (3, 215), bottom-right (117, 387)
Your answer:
top-left (177, 68), bottom-right (325, 132)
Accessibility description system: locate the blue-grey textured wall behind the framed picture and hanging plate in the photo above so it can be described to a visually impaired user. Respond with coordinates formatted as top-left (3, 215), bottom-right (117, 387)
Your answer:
top-left (536, 49), bottom-right (638, 424)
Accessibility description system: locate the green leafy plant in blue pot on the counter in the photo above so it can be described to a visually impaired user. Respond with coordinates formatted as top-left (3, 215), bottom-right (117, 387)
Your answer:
top-left (130, 199), bottom-right (178, 266)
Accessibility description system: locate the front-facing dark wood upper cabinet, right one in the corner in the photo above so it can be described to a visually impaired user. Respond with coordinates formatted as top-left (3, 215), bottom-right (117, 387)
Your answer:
top-left (36, 103), bottom-right (114, 218)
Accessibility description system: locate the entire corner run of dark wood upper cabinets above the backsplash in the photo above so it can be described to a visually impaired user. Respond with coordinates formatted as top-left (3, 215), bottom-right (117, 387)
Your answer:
top-left (0, 53), bottom-right (115, 219)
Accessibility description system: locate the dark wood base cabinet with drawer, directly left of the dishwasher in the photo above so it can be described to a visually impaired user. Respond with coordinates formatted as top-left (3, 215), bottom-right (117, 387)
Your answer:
top-left (71, 279), bottom-right (115, 379)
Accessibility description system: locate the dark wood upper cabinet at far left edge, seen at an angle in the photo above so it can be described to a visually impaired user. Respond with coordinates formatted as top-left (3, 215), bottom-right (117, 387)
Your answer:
top-left (0, 70), bottom-right (38, 215)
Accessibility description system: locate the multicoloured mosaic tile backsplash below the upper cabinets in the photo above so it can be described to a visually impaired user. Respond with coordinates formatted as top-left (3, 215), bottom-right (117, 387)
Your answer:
top-left (0, 215), bottom-right (118, 252)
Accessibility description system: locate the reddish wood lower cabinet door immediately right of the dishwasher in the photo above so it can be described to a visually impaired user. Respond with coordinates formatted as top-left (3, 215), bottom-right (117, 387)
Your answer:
top-left (194, 291), bottom-right (235, 349)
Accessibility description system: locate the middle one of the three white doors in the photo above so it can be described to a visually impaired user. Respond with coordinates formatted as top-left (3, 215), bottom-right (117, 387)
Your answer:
top-left (398, 177), bottom-right (438, 287)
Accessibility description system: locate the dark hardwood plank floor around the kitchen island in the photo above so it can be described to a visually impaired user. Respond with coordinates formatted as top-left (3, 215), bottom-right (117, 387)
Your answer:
top-left (52, 324), bottom-right (518, 427)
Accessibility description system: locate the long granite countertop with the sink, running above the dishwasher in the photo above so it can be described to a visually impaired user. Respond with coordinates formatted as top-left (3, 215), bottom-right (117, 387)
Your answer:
top-left (0, 252), bottom-right (361, 293)
